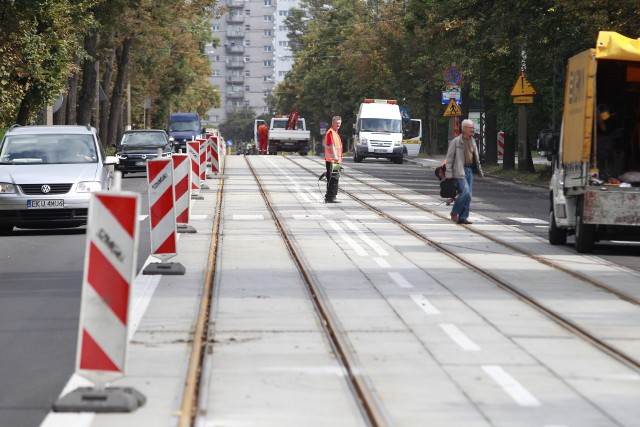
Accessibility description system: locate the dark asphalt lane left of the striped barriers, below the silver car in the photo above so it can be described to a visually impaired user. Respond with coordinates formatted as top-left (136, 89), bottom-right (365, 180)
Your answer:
top-left (0, 174), bottom-right (150, 427)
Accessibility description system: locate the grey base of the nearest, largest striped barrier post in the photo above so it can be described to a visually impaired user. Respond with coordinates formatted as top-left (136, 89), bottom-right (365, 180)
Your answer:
top-left (53, 387), bottom-right (147, 412)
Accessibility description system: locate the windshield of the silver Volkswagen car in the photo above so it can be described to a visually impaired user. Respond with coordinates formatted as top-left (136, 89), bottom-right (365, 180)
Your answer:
top-left (0, 134), bottom-right (98, 165)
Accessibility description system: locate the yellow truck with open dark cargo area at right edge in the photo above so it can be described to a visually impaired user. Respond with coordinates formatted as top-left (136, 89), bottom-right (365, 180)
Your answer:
top-left (538, 31), bottom-right (640, 253)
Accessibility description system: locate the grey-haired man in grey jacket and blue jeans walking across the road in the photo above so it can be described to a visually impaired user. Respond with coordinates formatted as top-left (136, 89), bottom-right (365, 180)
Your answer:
top-left (445, 119), bottom-right (484, 224)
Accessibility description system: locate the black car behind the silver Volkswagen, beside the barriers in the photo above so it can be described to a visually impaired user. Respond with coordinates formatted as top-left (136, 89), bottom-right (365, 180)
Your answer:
top-left (116, 129), bottom-right (173, 175)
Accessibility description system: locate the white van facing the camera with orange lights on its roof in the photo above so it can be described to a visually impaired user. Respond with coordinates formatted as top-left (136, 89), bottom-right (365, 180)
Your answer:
top-left (353, 99), bottom-right (404, 164)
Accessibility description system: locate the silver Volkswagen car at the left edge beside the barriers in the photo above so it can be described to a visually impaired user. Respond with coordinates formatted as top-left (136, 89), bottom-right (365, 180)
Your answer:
top-left (0, 125), bottom-right (118, 234)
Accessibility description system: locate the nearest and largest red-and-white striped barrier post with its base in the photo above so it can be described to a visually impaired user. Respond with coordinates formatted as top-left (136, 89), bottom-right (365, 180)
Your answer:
top-left (53, 182), bottom-right (146, 412)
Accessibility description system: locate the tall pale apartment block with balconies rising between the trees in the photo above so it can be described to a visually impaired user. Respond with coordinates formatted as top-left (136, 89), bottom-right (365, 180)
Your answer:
top-left (204, 0), bottom-right (299, 126)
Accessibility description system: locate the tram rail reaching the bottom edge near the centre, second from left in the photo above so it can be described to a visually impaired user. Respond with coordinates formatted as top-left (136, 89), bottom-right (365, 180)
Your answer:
top-left (245, 156), bottom-right (392, 427)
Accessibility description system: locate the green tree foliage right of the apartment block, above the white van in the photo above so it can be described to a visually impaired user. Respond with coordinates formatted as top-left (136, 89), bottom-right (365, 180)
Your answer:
top-left (274, 0), bottom-right (640, 159)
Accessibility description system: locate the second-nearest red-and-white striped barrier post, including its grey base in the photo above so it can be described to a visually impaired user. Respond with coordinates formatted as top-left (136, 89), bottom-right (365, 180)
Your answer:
top-left (142, 158), bottom-right (186, 275)
